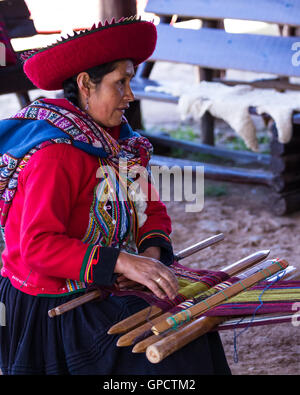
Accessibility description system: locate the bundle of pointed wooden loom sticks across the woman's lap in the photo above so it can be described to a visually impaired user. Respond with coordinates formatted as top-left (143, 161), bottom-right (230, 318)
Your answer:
top-left (48, 234), bottom-right (297, 363)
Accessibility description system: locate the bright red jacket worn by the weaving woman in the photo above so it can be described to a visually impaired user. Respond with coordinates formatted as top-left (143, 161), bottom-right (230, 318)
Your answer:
top-left (1, 144), bottom-right (171, 296)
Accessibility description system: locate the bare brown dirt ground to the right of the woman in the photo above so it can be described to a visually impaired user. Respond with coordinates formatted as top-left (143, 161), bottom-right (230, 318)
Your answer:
top-left (166, 181), bottom-right (300, 375)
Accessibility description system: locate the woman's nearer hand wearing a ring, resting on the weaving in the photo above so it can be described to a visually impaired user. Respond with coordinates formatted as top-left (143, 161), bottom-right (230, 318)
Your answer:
top-left (115, 251), bottom-right (178, 299)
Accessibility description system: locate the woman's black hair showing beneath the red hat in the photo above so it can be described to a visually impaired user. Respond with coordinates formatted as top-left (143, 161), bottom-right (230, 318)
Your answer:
top-left (63, 61), bottom-right (117, 107)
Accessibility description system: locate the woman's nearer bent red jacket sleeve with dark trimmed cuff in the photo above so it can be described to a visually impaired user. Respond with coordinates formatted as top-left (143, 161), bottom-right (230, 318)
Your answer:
top-left (20, 144), bottom-right (119, 285)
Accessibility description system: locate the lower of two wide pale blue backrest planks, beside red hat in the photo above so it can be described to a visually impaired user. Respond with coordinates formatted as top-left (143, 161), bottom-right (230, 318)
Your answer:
top-left (150, 24), bottom-right (300, 77)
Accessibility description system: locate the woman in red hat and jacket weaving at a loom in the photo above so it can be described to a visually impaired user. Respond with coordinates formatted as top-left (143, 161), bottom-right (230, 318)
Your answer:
top-left (0, 19), bottom-right (229, 374)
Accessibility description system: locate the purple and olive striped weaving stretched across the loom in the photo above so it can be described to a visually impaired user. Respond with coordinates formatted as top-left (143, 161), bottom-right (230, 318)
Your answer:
top-left (109, 262), bottom-right (300, 324)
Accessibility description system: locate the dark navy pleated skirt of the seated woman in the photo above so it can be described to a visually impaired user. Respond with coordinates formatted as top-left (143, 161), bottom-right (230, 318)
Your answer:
top-left (0, 276), bottom-right (230, 375)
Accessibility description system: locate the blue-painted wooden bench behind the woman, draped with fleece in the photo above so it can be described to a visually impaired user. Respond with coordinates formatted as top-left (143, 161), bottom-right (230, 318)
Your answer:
top-left (130, 0), bottom-right (300, 215)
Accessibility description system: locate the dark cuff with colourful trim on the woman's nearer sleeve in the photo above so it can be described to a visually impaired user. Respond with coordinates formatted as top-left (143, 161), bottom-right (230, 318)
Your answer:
top-left (81, 246), bottom-right (120, 286)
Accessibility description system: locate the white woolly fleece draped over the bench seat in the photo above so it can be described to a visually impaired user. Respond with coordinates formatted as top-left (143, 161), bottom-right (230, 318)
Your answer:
top-left (146, 81), bottom-right (300, 151)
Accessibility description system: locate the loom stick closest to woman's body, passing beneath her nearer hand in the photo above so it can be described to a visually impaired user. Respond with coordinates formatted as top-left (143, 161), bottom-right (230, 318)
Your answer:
top-left (48, 233), bottom-right (224, 318)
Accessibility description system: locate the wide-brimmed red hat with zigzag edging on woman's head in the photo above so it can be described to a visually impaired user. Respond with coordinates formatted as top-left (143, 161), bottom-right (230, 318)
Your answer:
top-left (22, 17), bottom-right (157, 90)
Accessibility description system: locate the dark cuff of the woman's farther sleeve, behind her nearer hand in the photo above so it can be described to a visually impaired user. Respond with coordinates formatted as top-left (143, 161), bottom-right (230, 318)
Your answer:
top-left (138, 231), bottom-right (174, 266)
